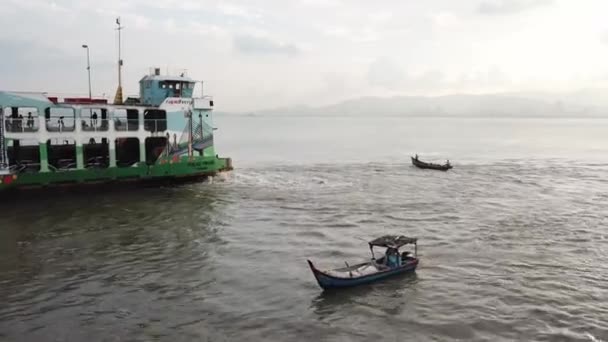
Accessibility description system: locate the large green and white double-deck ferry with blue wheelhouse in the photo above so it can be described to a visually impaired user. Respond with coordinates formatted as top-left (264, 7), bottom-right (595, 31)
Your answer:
top-left (0, 68), bottom-right (232, 192)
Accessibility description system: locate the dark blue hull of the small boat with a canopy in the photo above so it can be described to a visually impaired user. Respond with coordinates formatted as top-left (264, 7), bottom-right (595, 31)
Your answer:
top-left (308, 259), bottom-right (418, 290)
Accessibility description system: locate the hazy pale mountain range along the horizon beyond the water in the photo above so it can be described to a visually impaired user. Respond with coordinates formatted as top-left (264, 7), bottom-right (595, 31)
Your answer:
top-left (222, 91), bottom-right (608, 118)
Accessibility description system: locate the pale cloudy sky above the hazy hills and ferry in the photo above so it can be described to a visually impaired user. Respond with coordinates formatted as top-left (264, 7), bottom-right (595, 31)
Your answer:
top-left (0, 0), bottom-right (608, 111)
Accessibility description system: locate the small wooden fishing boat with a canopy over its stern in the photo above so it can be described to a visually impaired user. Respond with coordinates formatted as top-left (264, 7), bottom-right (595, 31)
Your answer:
top-left (307, 235), bottom-right (418, 290)
